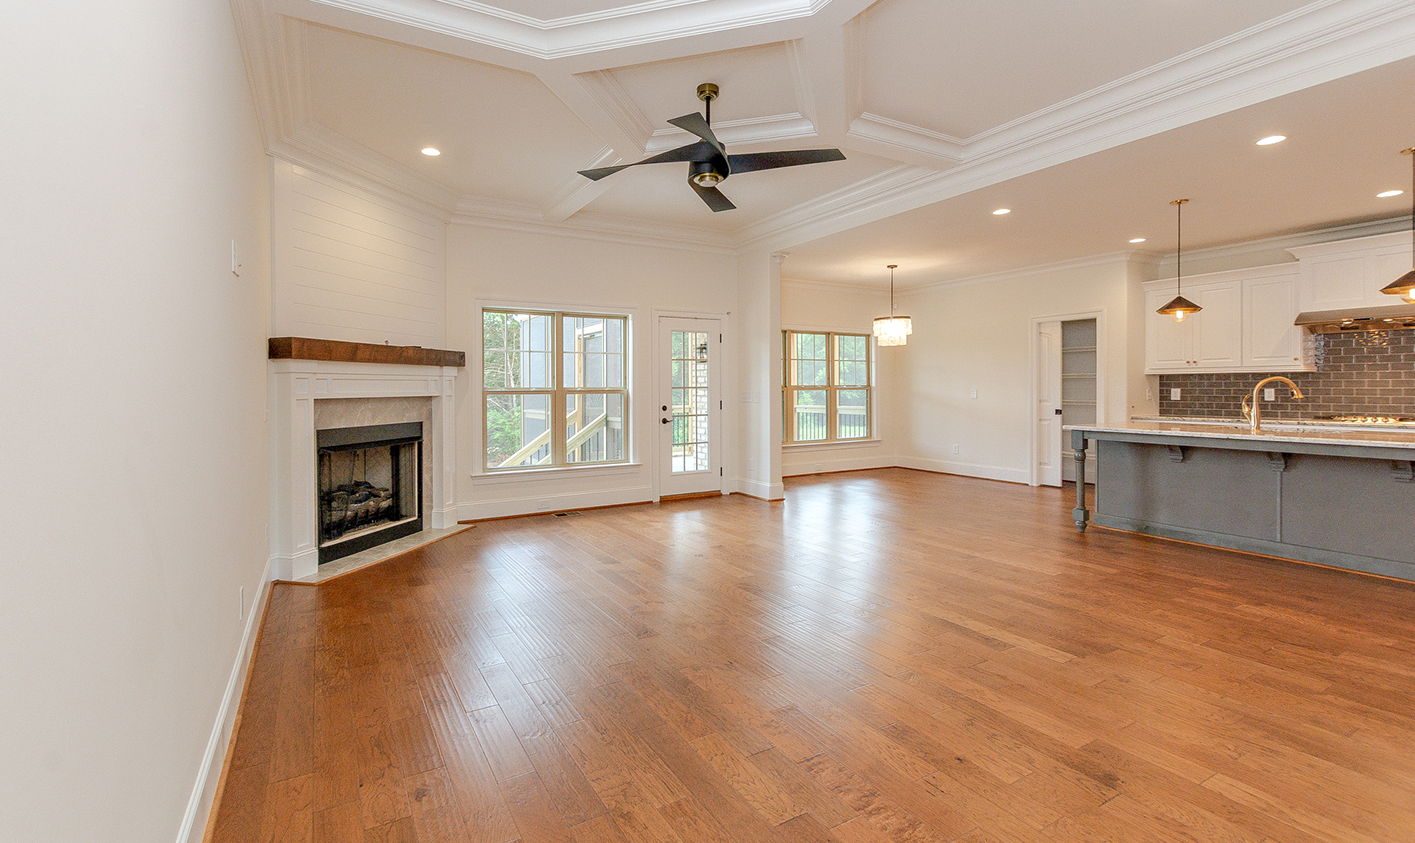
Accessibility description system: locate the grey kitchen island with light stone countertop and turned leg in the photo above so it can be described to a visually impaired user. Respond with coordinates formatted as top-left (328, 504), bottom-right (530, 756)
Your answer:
top-left (1065, 420), bottom-right (1415, 581)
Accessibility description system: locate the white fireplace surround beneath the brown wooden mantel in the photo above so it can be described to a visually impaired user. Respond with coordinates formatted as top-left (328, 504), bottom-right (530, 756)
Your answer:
top-left (269, 359), bottom-right (457, 580)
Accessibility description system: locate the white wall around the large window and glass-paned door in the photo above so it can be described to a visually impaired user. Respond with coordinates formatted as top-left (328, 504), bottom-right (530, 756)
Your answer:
top-left (447, 222), bottom-right (737, 519)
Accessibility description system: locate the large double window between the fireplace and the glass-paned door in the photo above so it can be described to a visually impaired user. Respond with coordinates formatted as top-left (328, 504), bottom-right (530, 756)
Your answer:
top-left (481, 310), bottom-right (628, 471)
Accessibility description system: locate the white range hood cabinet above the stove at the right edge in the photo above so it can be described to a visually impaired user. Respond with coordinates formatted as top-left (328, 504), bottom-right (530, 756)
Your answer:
top-left (1288, 231), bottom-right (1411, 313)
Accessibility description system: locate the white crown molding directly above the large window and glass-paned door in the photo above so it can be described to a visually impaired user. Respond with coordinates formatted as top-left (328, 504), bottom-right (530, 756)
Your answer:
top-left (449, 197), bottom-right (737, 255)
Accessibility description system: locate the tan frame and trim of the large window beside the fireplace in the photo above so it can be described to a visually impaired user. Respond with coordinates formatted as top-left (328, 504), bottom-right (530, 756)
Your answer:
top-left (478, 304), bottom-right (634, 475)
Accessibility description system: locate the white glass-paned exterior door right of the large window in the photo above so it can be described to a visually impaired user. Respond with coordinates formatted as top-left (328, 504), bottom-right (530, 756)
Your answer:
top-left (654, 317), bottom-right (723, 495)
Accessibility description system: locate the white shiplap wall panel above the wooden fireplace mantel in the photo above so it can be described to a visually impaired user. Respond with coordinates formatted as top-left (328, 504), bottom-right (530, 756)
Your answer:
top-left (270, 161), bottom-right (447, 348)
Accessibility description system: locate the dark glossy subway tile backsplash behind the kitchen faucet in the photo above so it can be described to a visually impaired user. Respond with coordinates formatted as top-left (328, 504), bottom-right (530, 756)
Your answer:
top-left (1159, 328), bottom-right (1415, 420)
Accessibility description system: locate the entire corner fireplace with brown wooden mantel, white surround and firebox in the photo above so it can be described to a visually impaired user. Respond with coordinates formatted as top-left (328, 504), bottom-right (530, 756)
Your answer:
top-left (269, 338), bottom-right (466, 580)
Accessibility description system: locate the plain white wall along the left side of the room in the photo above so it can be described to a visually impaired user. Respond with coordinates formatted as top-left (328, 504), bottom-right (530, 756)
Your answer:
top-left (0, 0), bottom-right (269, 843)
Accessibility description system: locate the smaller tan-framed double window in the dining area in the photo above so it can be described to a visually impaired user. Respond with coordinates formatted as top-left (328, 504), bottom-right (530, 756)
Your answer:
top-left (781, 331), bottom-right (872, 444)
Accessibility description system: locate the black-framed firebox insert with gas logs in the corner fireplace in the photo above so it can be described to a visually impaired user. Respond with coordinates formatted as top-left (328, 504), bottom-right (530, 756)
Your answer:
top-left (322, 422), bottom-right (423, 563)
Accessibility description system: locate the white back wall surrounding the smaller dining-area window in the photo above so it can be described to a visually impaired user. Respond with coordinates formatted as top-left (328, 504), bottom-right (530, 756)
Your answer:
top-left (781, 277), bottom-right (913, 477)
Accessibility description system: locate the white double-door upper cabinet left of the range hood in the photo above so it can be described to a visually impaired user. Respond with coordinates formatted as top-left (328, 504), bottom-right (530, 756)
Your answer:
top-left (1145, 264), bottom-right (1312, 375)
